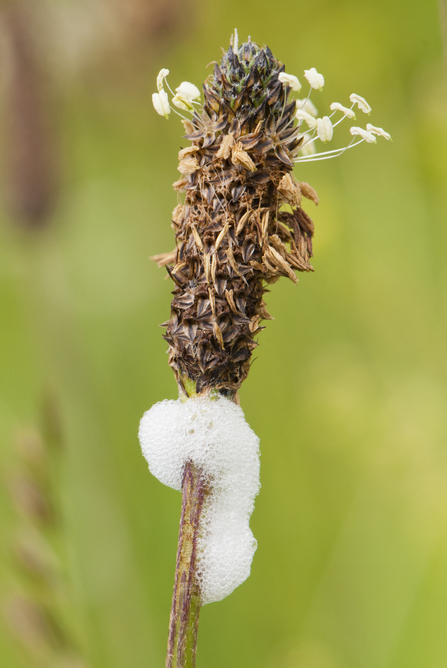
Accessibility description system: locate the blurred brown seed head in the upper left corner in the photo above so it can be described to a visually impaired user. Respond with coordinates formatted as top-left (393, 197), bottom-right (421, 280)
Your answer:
top-left (0, 3), bottom-right (58, 230)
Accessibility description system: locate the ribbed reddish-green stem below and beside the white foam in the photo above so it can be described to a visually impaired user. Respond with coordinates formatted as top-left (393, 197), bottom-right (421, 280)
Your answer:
top-left (166, 462), bottom-right (207, 668)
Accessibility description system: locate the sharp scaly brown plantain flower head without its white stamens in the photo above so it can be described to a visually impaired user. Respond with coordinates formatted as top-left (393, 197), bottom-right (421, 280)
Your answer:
top-left (154, 42), bottom-right (318, 394)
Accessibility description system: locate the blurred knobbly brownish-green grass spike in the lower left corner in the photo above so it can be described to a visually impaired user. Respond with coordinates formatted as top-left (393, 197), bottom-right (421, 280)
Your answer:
top-left (5, 404), bottom-right (87, 668)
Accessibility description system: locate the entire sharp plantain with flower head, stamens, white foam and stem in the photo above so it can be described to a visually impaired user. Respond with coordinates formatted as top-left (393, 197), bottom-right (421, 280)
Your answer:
top-left (146, 36), bottom-right (390, 668)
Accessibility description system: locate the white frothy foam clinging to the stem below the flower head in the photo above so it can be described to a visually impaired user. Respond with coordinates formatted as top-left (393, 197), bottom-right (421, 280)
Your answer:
top-left (139, 397), bottom-right (260, 604)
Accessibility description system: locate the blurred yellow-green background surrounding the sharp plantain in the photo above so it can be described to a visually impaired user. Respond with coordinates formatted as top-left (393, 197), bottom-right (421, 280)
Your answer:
top-left (0, 0), bottom-right (447, 668)
